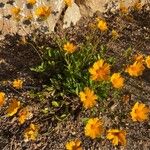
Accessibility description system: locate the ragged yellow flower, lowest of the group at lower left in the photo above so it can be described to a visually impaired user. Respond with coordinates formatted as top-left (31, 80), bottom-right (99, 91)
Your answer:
top-left (24, 123), bottom-right (39, 141)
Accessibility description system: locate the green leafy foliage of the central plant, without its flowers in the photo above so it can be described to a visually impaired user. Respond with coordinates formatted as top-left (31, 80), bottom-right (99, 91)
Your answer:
top-left (31, 39), bottom-right (113, 101)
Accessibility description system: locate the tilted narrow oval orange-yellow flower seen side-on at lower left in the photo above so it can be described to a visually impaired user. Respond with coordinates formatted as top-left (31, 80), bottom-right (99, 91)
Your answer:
top-left (6, 99), bottom-right (20, 117)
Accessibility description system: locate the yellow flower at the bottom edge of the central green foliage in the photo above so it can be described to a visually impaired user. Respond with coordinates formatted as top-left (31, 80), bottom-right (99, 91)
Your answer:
top-left (79, 87), bottom-right (97, 109)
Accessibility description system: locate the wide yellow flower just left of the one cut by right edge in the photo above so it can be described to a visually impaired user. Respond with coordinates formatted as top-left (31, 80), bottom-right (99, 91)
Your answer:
top-left (125, 61), bottom-right (145, 77)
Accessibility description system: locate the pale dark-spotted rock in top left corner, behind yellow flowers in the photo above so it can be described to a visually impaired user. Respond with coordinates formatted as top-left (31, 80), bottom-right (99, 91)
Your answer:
top-left (0, 0), bottom-right (65, 35)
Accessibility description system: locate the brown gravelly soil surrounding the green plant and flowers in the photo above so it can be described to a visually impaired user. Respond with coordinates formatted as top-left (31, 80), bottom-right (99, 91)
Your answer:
top-left (0, 0), bottom-right (150, 150)
